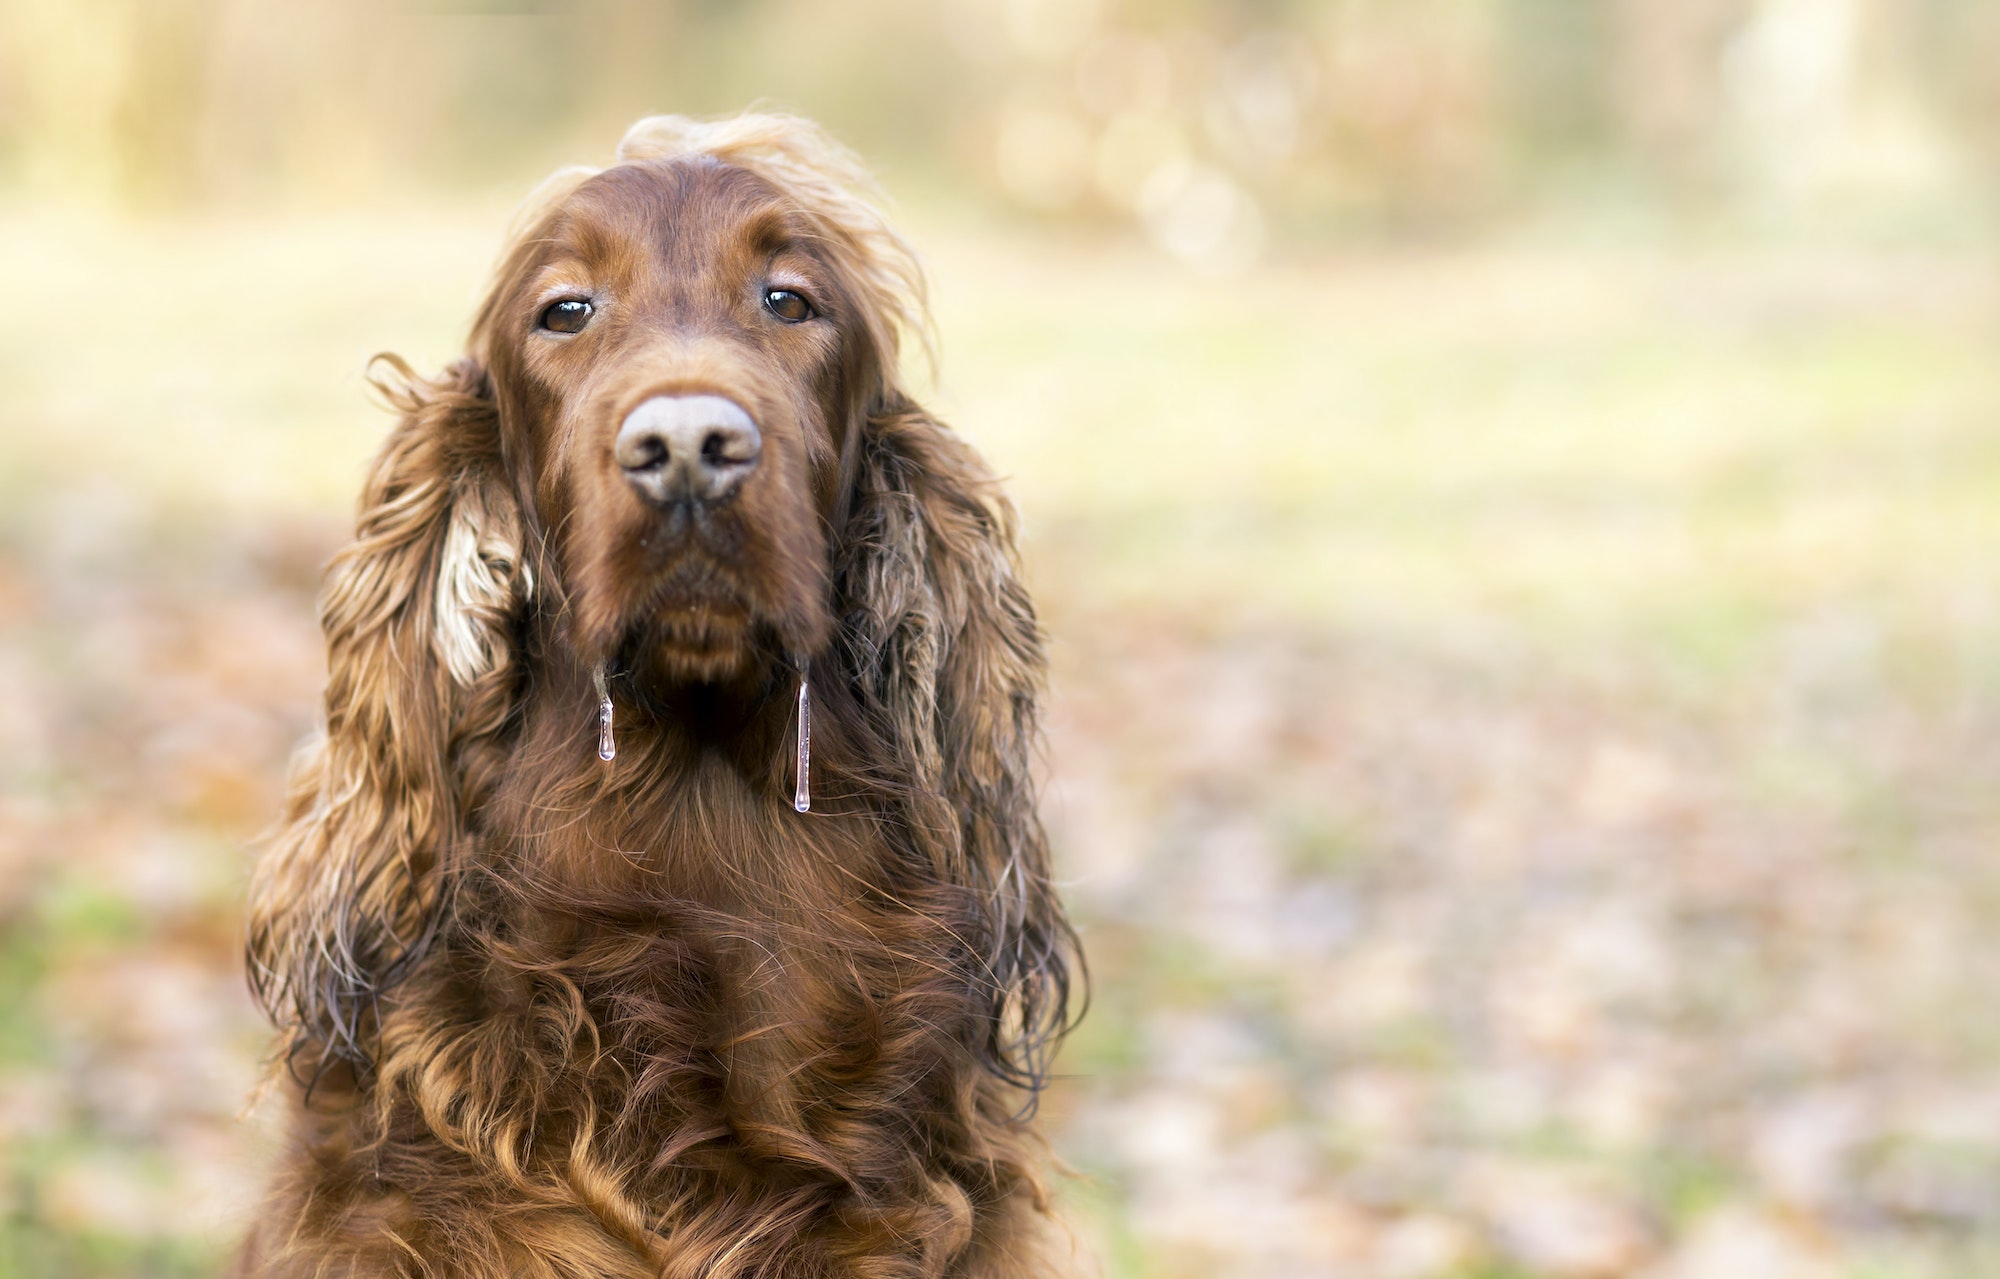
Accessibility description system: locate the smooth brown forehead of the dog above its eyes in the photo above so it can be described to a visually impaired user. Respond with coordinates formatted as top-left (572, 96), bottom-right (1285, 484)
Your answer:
top-left (558, 156), bottom-right (796, 264)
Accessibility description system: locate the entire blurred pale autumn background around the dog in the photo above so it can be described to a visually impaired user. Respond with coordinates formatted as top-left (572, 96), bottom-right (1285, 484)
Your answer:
top-left (0, 0), bottom-right (2000, 1279)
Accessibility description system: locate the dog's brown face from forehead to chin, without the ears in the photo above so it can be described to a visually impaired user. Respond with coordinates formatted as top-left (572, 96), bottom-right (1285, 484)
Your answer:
top-left (480, 160), bottom-right (878, 683)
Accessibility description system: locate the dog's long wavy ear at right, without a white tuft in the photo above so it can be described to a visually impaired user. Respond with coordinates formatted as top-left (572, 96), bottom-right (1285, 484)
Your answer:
top-left (836, 398), bottom-right (1078, 1105)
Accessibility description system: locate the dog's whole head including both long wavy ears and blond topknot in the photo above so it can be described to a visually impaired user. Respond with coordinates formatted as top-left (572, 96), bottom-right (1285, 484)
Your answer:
top-left (250, 116), bottom-right (1068, 1083)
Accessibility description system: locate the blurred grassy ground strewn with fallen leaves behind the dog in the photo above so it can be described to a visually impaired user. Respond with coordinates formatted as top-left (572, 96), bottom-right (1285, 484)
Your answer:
top-left (0, 206), bottom-right (2000, 1279)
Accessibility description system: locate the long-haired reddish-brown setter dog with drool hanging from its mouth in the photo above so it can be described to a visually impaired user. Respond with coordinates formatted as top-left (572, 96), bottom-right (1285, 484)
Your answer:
top-left (238, 116), bottom-right (1076, 1279)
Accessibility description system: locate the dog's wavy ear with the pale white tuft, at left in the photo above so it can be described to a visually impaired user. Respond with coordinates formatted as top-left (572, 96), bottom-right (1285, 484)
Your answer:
top-left (248, 358), bottom-right (530, 1077)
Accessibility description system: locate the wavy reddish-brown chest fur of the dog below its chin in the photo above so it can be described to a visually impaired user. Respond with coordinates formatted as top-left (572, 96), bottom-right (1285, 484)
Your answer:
top-left (262, 753), bottom-right (1008, 1269)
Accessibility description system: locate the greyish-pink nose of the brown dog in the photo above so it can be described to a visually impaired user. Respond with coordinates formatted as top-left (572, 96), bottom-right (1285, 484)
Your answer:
top-left (612, 396), bottom-right (764, 506)
